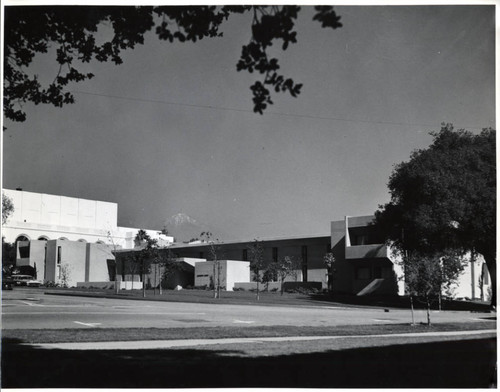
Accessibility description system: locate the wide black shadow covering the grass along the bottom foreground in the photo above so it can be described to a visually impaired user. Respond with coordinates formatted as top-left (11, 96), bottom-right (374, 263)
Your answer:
top-left (2, 339), bottom-right (496, 388)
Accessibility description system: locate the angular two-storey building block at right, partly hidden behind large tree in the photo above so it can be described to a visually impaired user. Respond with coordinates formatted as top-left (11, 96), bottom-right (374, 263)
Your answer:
top-left (331, 215), bottom-right (491, 301)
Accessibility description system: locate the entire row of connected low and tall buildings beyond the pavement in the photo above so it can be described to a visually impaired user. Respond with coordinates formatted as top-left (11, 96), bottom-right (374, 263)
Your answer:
top-left (2, 190), bottom-right (491, 300)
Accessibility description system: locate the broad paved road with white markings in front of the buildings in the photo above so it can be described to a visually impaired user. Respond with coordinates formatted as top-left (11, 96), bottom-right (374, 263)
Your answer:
top-left (2, 289), bottom-right (495, 329)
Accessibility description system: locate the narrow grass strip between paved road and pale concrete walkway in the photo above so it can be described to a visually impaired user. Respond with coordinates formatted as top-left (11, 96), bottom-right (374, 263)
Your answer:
top-left (2, 321), bottom-right (496, 343)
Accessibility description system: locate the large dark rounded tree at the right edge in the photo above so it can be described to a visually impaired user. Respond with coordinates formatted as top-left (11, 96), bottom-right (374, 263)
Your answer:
top-left (375, 124), bottom-right (496, 306)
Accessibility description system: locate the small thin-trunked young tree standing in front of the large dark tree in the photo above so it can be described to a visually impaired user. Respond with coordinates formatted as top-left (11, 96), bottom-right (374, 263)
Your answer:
top-left (403, 252), bottom-right (465, 325)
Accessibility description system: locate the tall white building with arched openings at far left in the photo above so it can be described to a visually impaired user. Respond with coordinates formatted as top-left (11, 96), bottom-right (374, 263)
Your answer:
top-left (2, 189), bottom-right (173, 286)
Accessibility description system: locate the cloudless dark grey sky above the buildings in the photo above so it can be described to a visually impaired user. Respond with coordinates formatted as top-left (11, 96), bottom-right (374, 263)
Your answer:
top-left (3, 6), bottom-right (495, 240)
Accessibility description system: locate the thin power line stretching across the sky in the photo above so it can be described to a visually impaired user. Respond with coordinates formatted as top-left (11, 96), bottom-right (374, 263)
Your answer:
top-left (71, 91), bottom-right (492, 129)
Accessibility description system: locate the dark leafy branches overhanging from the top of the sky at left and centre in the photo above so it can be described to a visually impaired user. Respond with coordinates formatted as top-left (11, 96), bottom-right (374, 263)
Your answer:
top-left (4, 6), bottom-right (342, 121)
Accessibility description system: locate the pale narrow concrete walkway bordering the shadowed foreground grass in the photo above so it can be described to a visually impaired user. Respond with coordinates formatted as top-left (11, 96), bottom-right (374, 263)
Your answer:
top-left (28, 329), bottom-right (497, 350)
